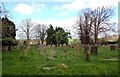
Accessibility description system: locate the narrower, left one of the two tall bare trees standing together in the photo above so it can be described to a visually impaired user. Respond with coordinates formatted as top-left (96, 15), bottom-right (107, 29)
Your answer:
top-left (76, 9), bottom-right (93, 44)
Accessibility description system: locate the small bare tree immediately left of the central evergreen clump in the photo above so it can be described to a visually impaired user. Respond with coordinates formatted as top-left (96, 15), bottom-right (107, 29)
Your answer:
top-left (35, 24), bottom-right (47, 44)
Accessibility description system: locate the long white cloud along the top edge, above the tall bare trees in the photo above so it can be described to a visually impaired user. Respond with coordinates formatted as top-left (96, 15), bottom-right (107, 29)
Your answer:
top-left (55, 0), bottom-right (119, 10)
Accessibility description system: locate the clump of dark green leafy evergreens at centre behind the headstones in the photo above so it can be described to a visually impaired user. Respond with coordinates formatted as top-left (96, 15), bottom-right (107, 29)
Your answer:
top-left (47, 25), bottom-right (70, 45)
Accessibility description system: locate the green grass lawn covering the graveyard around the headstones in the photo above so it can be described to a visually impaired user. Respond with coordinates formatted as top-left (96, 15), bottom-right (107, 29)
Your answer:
top-left (2, 47), bottom-right (118, 75)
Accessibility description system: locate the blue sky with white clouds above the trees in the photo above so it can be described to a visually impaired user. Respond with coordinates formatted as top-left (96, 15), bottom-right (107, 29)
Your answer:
top-left (1, 0), bottom-right (119, 39)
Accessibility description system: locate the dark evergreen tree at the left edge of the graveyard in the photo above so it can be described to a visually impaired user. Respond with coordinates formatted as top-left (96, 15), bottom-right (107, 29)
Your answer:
top-left (2, 17), bottom-right (17, 46)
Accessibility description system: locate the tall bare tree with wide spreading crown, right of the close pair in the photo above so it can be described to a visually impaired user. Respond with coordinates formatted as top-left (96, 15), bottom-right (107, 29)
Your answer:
top-left (91, 6), bottom-right (115, 44)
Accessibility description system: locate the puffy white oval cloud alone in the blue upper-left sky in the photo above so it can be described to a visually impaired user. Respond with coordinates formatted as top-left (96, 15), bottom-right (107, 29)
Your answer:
top-left (14, 3), bottom-right (34, 14)
